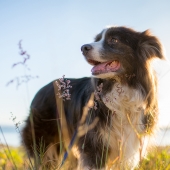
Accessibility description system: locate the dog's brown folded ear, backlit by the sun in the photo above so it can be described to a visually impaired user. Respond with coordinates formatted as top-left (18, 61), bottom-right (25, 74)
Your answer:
top-left (137, 30), bottom-right (165, 59)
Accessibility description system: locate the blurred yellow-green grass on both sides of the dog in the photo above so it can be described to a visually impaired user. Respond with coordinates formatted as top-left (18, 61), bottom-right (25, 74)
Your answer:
top-left (0, 145), bottom-right (170, 170)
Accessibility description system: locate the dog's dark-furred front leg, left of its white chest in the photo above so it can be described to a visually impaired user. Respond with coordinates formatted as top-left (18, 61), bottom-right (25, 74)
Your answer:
top-left (77, 135), bottom-right (109, 170)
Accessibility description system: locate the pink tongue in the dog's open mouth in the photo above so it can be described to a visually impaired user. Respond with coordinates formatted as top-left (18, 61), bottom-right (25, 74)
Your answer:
top-left (91, 61), bottom-right (120, 74)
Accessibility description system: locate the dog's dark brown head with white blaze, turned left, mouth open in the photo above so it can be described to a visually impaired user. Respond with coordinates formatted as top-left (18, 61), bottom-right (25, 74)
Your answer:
top-left (81, 27), bottom-right (164, 79)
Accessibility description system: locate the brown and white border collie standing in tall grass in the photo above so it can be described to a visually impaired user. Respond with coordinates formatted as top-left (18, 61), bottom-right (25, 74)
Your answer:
top-left (22, 26), bottom-right (164, 170)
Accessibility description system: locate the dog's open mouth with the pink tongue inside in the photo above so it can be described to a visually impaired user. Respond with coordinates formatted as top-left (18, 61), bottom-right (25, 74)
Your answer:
top-left (88, 60), bottom-right (120, 75)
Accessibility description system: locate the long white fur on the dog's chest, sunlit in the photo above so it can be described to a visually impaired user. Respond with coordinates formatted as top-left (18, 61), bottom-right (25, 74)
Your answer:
top-left (101, 83), bottom-right (149, 169)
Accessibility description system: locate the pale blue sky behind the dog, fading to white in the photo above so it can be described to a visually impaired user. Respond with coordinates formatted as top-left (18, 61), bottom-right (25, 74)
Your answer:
top-left (0, 0), bottom-right (170, 133)
